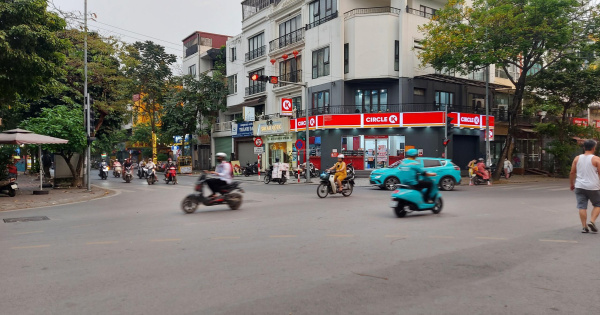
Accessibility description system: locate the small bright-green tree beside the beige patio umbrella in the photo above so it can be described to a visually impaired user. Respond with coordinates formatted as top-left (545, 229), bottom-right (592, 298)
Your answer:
top-left (22, 105), bottom-right (87, 187)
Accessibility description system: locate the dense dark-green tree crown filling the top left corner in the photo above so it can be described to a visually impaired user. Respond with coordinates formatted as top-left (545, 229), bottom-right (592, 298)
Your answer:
top-left (0, 0), bottom-right (69, 107)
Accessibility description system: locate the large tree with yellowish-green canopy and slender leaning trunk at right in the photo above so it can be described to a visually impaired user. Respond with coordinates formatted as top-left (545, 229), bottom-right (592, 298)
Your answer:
top-left (420, 0), bottom-right (600, 179)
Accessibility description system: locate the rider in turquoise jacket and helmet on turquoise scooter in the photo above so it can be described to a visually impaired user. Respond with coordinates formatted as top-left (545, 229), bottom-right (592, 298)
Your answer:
top-left (400, 149), bottom-right (437, 203)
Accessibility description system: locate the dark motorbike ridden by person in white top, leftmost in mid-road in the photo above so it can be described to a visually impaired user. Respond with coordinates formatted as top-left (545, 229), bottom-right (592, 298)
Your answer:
top-left (181, 174), bottom-right (244, 213)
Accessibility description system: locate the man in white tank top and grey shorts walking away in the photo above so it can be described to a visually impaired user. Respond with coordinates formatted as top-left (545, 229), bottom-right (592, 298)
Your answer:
top-left (569, 140), bottom-right (600, 233)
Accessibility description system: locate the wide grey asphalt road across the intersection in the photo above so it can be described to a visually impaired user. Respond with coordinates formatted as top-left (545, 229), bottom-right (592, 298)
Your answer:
top-left (0, 177), bottom-right (600, 315)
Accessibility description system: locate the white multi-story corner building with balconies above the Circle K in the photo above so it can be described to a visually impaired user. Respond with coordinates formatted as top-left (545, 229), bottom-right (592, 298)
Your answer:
top-left (220, 0), bottom-right (510, 173)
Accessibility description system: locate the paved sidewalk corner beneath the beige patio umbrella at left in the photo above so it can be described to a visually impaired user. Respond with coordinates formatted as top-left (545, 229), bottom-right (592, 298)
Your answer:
top-left (0, 175), bottom-right (114, 211)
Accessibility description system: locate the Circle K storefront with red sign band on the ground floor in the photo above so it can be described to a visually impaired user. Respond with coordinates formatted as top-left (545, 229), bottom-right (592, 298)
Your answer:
top-left (290, 111), bottom-right (494, 170)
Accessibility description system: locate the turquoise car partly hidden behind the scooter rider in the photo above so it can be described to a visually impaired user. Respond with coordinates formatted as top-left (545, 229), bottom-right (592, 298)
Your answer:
top-left (369, 157), bottom-right (461, 191)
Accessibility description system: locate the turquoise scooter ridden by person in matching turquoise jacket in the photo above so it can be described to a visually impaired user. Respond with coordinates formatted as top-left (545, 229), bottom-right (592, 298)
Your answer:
top-left (390, 177), bottom-right (444, 218)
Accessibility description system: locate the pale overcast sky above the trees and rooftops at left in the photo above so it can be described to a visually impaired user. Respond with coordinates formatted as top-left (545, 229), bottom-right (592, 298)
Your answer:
top-left (53, 0), bottom-right (242, 63)
